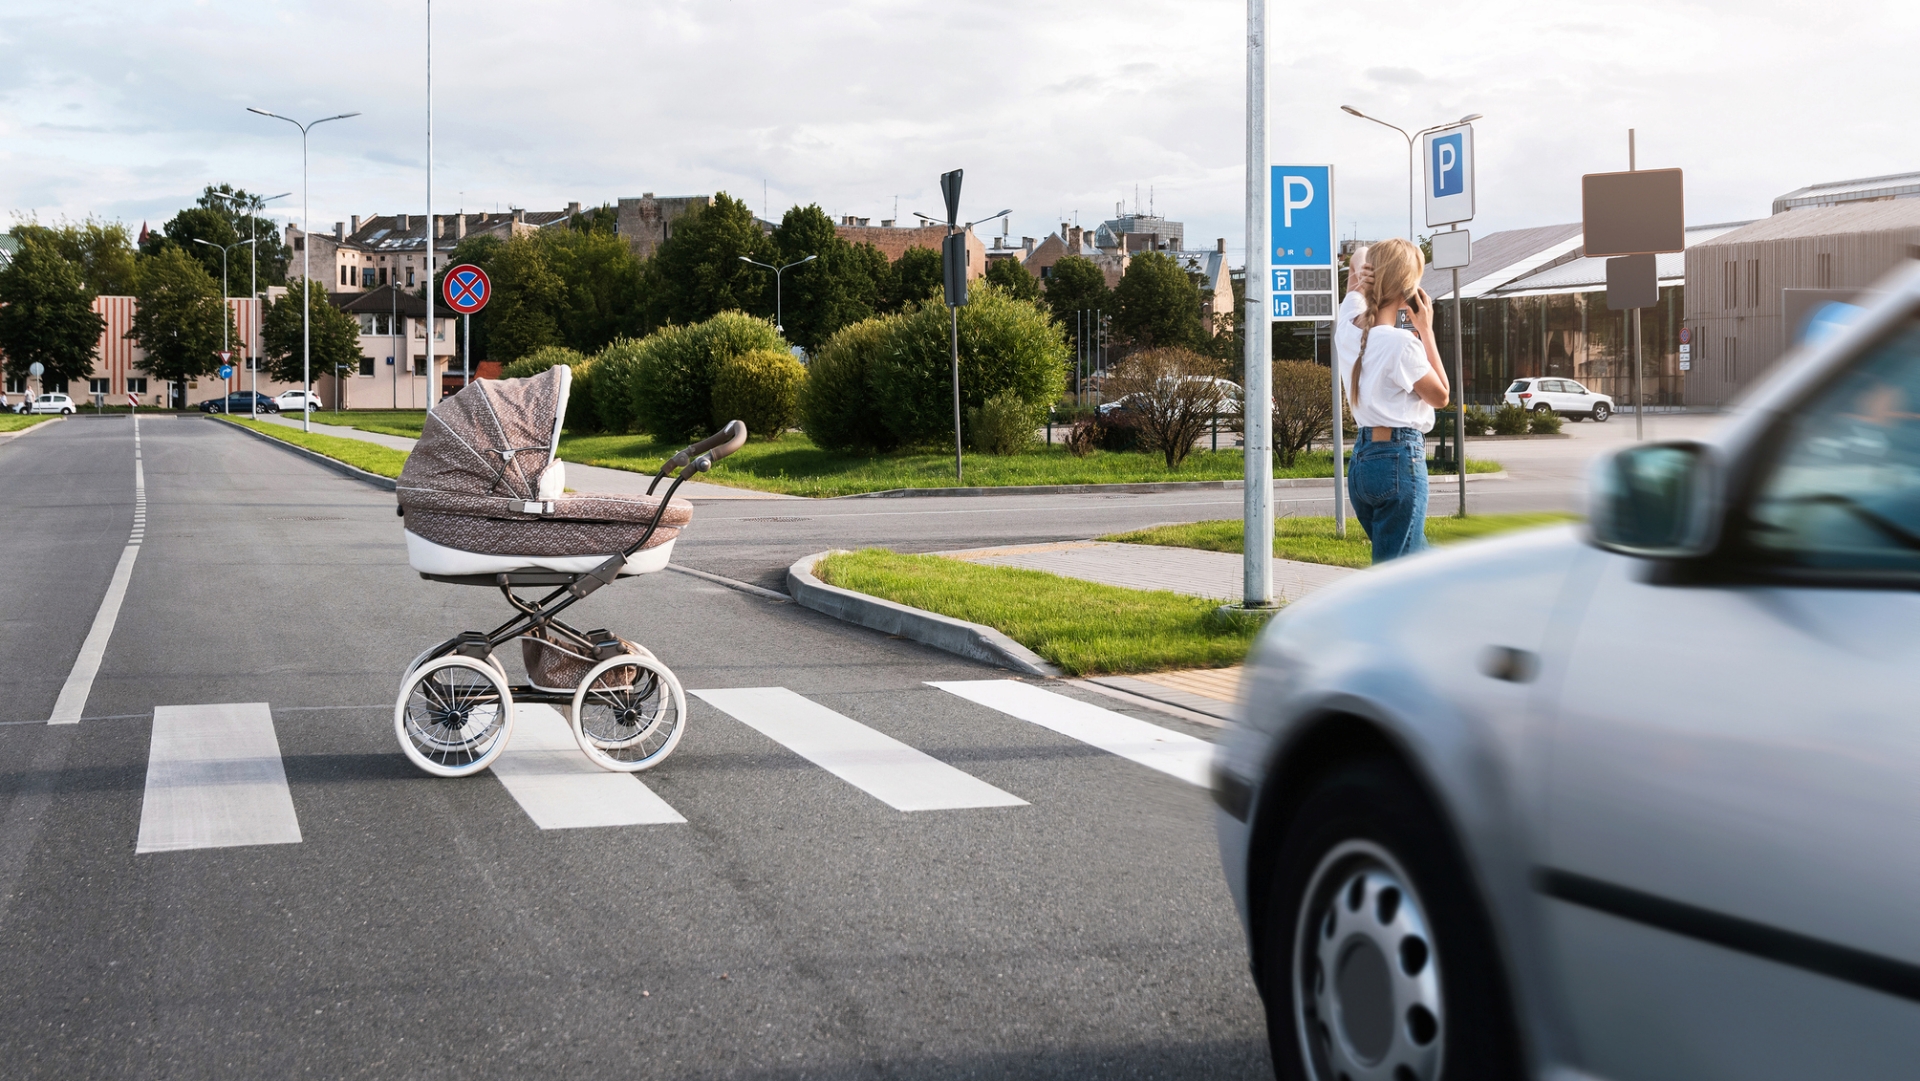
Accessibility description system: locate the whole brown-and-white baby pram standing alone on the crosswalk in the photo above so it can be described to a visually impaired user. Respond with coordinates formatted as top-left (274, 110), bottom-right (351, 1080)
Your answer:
top-left (394, 365), bottom-right (747, 778)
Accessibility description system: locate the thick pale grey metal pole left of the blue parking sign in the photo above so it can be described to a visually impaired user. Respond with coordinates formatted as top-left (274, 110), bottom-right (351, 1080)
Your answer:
top-left (1240, 0), bottom-right (1273, 609)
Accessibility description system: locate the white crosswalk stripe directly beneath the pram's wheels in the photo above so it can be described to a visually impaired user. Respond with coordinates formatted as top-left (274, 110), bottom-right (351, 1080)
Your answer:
top-left (493, 705), bottom-right (685, 829)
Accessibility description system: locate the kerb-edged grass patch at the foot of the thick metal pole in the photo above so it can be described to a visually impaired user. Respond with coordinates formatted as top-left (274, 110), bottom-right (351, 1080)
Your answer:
top-left (814, 547), bottom-right (1258, 676)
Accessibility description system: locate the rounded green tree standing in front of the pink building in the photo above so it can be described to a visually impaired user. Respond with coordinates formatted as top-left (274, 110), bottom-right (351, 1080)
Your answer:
top-left (127, 246), bottom-right (239, 403)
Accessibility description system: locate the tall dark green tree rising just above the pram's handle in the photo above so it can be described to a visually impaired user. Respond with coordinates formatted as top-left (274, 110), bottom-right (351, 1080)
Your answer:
top-left (645, 192), bottom-right (774, 328)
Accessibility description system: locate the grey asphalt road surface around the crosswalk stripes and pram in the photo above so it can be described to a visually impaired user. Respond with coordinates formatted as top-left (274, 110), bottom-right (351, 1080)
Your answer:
top-left (0, 417), bottom-right (1269, 1079)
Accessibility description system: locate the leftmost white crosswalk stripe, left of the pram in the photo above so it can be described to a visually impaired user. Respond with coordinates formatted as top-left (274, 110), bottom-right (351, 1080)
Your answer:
top-left (134, 703), bottom-right (300, 853)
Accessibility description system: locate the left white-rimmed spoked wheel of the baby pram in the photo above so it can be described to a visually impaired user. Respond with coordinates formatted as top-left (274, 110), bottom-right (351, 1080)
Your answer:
top-left (394, 655), bottom-right (513, 778)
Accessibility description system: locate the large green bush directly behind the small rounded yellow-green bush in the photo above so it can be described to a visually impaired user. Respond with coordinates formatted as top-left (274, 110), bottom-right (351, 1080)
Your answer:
top-left (626, 311), bottom-right (787, 440)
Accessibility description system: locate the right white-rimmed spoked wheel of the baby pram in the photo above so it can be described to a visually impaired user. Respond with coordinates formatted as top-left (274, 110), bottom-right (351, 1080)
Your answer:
top-left (572, 653), bottom-right (687, 774)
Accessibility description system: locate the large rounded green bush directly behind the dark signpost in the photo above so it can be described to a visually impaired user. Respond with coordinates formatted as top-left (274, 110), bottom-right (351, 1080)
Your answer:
top-left (868, 282), bottom-right (1068, 444)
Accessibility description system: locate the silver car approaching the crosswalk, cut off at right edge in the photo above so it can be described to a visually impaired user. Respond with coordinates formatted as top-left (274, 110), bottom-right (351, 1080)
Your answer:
top-left (1213, 263), bottom-right (1920, 1081)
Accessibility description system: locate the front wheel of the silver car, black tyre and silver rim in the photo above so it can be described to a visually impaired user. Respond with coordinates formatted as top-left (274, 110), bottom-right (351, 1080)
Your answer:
top-left (1256, 758), bottom-right (1523, 1081)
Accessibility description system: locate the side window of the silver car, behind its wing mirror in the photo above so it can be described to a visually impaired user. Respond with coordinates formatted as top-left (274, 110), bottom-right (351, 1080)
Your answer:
top-left (1747, 323), bottom-right (1920, 578)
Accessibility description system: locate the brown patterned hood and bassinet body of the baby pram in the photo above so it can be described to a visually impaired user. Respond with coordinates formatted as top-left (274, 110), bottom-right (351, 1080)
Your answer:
top-left (396, 365), bottom-right (693, 557)
